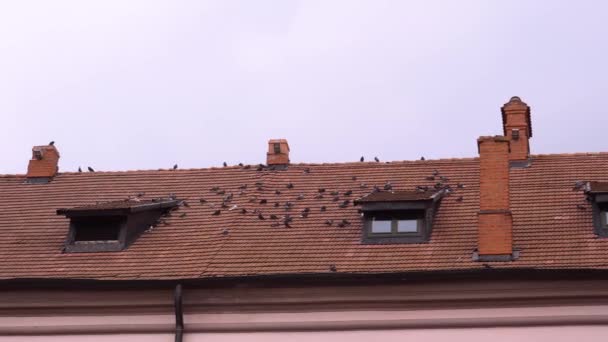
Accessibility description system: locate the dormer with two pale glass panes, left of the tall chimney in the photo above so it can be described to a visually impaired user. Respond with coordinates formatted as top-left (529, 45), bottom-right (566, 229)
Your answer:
top-left (355, 191), bottom-right (443, 243)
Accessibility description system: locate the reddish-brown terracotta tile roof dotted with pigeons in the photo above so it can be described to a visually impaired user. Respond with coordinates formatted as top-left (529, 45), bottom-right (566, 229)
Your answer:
top-left (0, 153), bottom-right (608, 280)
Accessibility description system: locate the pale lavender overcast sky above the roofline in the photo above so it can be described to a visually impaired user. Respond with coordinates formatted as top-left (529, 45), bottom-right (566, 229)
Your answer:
top-left (0, 0), bottom-right (608, 174)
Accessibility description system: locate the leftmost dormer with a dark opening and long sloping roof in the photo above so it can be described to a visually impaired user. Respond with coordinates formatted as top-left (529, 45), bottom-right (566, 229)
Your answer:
top-left (57, 199), bottom-right (179, 253)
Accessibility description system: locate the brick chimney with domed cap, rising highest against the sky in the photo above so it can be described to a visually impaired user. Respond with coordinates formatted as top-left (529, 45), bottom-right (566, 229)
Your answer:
top-left (502, 96), bottom-right (532, 166)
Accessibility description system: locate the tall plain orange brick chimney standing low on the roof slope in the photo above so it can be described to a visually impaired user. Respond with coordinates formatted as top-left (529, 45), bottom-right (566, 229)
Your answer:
top-left (474, 136), bottom-right (513, 261)
